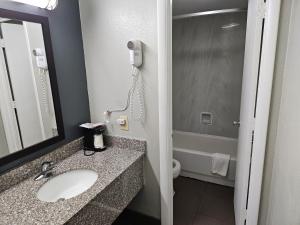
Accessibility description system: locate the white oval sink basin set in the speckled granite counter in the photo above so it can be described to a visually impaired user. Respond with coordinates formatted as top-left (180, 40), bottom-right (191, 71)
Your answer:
top-left (37, 169), bottom-right (98, 202)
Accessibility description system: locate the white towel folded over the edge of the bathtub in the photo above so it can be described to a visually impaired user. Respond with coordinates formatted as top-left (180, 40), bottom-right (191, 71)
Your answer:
top-left (211, 153), bottom-right (230, 177)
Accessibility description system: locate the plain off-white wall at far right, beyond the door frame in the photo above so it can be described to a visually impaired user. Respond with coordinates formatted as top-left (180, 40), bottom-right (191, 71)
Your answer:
top-left (261, 0), bottom-right (300, 225)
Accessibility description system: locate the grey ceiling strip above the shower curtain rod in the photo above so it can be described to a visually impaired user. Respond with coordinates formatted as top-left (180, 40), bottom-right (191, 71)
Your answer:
top-left (173, 0), bottom-right (248, 15)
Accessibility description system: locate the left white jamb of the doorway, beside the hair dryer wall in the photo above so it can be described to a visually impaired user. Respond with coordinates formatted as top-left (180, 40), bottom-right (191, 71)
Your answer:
top-left (157, 0), bottom-right (173, 225)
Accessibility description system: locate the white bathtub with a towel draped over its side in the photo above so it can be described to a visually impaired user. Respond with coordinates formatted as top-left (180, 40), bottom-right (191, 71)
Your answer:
top-left (173, 131), bottom-right (237, 187)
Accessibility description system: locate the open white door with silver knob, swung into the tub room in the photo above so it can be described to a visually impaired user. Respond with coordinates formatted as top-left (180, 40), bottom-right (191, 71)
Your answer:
top-left (234, 1), bottom-right (262, 222)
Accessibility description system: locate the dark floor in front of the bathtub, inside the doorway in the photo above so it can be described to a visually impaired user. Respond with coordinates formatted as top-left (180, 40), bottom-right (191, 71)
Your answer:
top-left (174, 177), bottom-right (235, 225)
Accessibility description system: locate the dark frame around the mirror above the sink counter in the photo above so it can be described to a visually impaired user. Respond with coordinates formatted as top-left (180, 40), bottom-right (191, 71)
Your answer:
top-left (0, 9), bottom-right (65, 174)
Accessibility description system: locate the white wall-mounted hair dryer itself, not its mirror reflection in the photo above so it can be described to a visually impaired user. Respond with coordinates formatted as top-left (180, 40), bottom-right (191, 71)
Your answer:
top-left (127, 40), bottom-right (143, 67)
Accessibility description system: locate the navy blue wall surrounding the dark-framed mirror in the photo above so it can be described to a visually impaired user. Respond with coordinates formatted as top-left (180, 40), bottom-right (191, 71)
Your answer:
top-left (0, 0), bottom-right (90, 171)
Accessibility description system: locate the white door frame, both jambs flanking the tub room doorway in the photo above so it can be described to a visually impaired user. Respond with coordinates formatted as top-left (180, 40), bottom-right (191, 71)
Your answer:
top-left (157, 0), bottom-right (281, 225)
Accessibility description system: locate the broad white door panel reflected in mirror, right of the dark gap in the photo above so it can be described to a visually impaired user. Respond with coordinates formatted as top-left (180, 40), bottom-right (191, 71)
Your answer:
top-left (1, 23), bottom-right (43, 148)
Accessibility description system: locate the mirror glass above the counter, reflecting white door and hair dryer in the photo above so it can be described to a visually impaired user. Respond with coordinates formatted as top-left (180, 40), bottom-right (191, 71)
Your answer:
top-left (0, 18), bottom-right (58, 158)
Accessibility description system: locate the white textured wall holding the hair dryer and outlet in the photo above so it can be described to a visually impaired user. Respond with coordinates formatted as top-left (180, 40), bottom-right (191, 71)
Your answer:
top-left (79, 0), bottom-right (160, 218)
